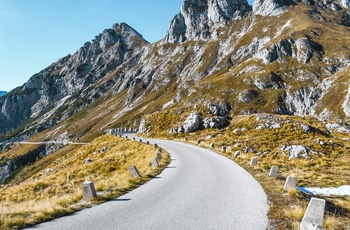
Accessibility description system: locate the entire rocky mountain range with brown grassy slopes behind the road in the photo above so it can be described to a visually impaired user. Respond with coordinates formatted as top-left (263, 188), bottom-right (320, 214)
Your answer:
top-left (0, 0), bottom-right (350, 138)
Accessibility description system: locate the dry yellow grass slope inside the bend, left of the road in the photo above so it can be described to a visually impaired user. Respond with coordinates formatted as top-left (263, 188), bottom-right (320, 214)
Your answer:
top-left (0, 135), bottom-right (170, 229)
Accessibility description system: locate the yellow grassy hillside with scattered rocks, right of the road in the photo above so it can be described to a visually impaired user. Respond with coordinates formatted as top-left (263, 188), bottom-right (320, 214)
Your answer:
top-left (141, 108), bottom-right (350, 229)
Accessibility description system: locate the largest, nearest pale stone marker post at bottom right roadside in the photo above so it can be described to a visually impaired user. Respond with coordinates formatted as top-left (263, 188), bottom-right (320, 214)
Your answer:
top-left (300, 198), bottom-right (326, 230)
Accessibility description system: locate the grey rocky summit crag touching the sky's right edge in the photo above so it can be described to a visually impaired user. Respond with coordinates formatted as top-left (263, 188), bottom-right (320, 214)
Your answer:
top-left (166, 0), bottom-right (250, 43)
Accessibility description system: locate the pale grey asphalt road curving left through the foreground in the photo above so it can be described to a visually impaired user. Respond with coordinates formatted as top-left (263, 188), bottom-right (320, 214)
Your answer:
top-left (31, 135), bottom-right (268, 230)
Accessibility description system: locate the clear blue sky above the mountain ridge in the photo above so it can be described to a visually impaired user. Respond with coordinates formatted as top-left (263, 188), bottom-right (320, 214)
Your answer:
top-left (0, 0), bottom-right (253, 91)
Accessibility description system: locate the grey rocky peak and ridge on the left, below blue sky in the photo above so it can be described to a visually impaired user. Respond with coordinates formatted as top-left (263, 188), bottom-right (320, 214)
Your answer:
top-left (0, 23), bottom-right (149, 133)
